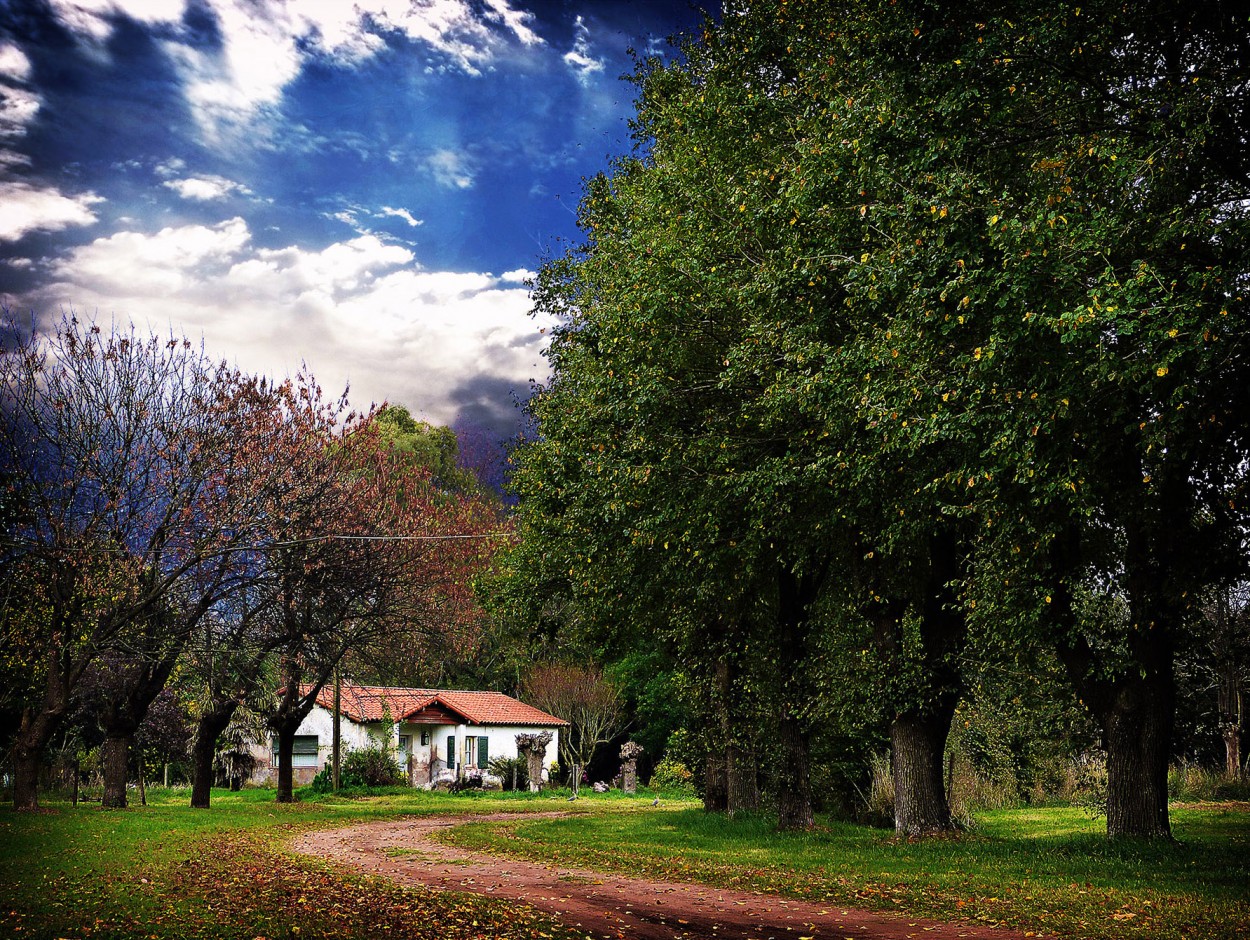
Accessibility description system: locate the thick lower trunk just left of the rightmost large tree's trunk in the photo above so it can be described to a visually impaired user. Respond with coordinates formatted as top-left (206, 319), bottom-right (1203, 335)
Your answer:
top-left (890, 696), bottom-right (956, 836)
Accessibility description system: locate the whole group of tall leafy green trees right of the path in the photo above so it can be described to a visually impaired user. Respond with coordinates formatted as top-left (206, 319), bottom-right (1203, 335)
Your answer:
top-left (500, 0), bottom-right (1250, 835)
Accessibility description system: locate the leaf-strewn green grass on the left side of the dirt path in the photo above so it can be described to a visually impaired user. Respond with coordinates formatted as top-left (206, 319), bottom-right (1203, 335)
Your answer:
top-left (0, 790), bottom-right (585, 940)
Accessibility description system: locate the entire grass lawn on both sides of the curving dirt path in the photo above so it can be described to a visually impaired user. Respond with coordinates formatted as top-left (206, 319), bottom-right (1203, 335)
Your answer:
top-left (0, 790), bottom-right (1250, 940)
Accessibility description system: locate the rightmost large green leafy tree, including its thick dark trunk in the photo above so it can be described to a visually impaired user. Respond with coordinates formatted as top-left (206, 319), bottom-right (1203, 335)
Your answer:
top-left (750, 3), bottom-right (1250, 836)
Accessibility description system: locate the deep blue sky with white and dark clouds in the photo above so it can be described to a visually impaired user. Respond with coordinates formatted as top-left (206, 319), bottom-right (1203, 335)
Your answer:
top-left (0, 0), bottom-right (714, 438)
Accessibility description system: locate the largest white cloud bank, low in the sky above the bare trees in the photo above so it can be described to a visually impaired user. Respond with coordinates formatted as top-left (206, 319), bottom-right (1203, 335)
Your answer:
top-left (16, 219), bottom-right (545, 423)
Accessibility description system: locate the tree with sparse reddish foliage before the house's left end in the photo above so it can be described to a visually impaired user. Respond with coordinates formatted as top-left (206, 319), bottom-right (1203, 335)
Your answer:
top-left (258, 381), bottom-right (498, 801)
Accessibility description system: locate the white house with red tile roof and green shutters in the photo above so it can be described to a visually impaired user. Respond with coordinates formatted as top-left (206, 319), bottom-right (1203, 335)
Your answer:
top-left (253, 683), bottom-right (569, 786)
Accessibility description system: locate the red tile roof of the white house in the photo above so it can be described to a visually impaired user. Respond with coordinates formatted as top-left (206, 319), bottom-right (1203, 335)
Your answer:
top-left (316, 683), bottom-right (569, 728)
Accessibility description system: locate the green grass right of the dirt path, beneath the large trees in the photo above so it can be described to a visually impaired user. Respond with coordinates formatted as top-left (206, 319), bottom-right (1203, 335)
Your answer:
top-left (443, 806), bottom-right (1250, 940)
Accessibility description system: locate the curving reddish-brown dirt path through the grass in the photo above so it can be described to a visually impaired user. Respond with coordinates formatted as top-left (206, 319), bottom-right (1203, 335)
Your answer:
top-left (293, 814), bottom-right (1041, 940)
